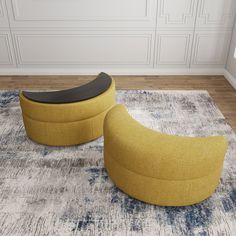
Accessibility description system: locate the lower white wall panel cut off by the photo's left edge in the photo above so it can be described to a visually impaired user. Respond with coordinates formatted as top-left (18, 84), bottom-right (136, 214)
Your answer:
top-left (0, 30), bottom-right (15, 67)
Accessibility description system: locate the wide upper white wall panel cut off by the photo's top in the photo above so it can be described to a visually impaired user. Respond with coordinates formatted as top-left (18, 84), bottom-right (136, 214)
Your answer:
top-left (7, 0), bottom-right (156, 27)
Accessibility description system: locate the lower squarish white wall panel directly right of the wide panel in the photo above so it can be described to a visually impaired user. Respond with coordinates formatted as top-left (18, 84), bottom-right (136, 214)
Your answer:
top-left (156, 31), bottom-right (193, 68)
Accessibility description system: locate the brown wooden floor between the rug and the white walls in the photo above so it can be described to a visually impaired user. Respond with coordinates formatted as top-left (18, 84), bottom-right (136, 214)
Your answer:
top-left (0, 76), bottom-right (236, 131)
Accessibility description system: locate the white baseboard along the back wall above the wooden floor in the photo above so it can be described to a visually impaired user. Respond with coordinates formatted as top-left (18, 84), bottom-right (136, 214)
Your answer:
top-left (0, 68), bottom-right (225, 75)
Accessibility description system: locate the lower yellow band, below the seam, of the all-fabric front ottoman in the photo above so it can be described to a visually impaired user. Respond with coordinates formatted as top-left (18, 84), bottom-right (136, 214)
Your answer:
top-left (104, 153), bottom-right (221, 206)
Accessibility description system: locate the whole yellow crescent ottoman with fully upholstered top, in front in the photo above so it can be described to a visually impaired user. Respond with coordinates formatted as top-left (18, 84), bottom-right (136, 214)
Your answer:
top-left (104, 105), bottom-right (227, 206)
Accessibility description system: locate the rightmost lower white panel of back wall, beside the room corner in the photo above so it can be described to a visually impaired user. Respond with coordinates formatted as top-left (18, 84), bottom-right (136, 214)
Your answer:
top-left (192, 31), bottom-right (231, 67)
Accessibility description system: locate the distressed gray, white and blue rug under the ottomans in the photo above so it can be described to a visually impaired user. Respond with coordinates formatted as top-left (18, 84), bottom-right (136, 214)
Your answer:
top-left (0, 91), bottom-right (236, 236)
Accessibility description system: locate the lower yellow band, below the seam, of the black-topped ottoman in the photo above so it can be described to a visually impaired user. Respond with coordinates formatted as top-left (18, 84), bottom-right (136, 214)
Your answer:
top-left (23, 110), bottom-right (108, 146)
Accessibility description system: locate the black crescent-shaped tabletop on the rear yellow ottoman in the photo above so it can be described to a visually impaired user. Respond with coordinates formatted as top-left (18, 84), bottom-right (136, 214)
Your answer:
top-left (22, 72), bottom-right (112, 104)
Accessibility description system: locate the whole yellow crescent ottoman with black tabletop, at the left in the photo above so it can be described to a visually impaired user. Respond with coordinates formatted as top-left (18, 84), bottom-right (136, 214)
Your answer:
top-left (20, 73), bottom-right (115, 146)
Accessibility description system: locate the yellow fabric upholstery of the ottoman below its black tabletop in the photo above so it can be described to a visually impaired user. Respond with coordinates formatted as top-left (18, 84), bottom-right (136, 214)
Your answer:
top-left (20, 80), bottom-right (115, 146)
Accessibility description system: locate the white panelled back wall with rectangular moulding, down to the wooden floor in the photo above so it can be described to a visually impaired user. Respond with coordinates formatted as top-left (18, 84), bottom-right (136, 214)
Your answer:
top-left (0, 0), bottom-right (236, 74)
